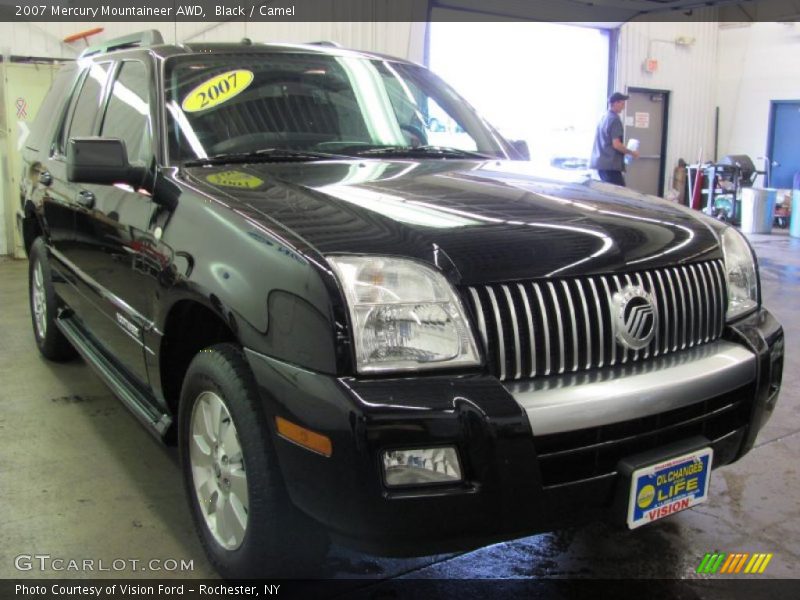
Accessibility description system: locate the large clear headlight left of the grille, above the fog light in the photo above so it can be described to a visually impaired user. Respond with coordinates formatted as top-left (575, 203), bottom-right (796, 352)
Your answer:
top-left (327, 256), bottom-right (480, 373)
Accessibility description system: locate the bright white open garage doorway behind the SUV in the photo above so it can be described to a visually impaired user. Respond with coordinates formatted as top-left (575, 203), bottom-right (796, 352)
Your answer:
top-left (428, 20), bottom-right (611, 172)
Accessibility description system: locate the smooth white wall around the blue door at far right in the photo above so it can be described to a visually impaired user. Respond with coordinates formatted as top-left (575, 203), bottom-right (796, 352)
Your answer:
top-left (716, 23), bottom-right (800, 164)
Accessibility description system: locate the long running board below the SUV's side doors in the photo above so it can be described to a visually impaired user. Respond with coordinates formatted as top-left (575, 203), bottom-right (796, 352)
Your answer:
top-left (56, 314), bottom-right (172, 440)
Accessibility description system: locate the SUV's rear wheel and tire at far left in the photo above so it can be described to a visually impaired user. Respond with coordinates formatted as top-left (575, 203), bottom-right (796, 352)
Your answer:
top-left (28, 237), bottom-right (77, 362)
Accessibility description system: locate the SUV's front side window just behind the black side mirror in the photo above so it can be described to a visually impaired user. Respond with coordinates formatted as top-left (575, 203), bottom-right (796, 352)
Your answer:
top-left (100, 61), bottom-right (153, 166)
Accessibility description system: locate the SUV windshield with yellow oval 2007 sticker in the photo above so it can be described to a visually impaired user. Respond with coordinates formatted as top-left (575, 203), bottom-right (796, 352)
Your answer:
top-left (166, 52), bottom-right (509, 163)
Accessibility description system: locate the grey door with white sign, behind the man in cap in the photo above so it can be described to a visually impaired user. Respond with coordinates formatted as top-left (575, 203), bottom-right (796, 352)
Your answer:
top-left (625, 88), bottom-right (669, 196)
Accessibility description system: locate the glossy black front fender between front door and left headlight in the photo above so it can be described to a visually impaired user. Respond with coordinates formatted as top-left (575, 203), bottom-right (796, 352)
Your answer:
top-left (155, 183), bottom-right (342, 374)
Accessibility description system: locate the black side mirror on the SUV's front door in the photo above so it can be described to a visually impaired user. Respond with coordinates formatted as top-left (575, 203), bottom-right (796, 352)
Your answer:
top-left (67, 137), bottom-right (147, 187)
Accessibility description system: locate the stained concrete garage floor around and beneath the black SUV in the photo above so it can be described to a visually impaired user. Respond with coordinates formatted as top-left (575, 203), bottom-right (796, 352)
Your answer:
top-left (0, 231), bottom-right (800, 598)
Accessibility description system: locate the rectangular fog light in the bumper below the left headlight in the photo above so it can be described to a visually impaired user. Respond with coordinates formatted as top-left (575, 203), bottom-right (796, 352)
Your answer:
top-left (383, 446), bottom-right (461, 487)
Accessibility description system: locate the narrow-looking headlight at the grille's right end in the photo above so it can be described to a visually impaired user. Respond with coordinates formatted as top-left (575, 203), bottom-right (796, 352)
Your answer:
top-left (722, 227), bottom-right (758, 321)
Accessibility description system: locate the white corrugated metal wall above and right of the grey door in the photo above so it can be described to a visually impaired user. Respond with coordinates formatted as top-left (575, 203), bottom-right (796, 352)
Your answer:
top-left (616, 15), bottom-right (719, 189)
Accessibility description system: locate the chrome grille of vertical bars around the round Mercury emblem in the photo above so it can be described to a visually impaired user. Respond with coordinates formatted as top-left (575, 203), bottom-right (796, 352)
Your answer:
top-left (466, 260), bottom-right (727, 380)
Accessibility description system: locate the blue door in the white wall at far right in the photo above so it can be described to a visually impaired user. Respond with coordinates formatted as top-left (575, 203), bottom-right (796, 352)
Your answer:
top-left (767, 100), bottom-right (800, 188)
